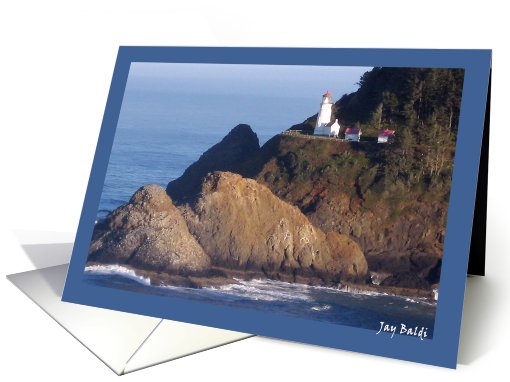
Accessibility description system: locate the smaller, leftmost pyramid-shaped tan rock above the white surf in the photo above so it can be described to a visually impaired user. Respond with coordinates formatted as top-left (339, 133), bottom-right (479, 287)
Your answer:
top-left (88, 185), bottom-right (210, 274)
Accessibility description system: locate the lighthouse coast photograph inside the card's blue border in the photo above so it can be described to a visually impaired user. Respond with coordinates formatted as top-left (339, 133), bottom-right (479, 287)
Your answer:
top-left (84, 62), bottom-right (464, 340)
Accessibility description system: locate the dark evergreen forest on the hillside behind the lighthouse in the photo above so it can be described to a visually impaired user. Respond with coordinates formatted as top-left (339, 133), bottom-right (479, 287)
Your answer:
top-left (291, 67), bottom-right (464, 198)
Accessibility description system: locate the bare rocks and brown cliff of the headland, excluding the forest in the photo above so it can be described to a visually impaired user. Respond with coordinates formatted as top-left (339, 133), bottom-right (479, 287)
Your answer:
top-left (88, 125), bottom-right (445, 297)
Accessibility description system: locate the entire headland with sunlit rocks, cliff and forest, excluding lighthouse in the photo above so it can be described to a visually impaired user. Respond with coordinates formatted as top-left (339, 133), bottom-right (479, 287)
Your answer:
top-left (88, 67), bottom-right (464, 302)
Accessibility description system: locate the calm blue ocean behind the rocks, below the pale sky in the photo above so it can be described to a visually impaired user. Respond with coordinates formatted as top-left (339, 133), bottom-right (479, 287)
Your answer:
top-left (98, 92), bottom-right (320, 218)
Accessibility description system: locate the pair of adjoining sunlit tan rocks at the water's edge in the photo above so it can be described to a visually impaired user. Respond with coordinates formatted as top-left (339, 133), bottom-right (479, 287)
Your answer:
top-left (88, 172), bottom-right (368, 286)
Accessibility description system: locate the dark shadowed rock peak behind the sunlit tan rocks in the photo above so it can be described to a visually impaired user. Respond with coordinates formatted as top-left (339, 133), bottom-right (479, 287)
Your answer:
top-left (166, 124), bottom-right (260, 202)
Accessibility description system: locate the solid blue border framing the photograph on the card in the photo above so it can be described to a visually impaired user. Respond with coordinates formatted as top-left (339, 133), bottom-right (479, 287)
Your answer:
top-left (62, 47), bottom-right (492, 368)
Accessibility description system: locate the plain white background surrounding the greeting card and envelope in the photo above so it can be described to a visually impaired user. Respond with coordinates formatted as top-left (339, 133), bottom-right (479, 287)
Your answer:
top-left (0, 0), bottom-right (510, 382)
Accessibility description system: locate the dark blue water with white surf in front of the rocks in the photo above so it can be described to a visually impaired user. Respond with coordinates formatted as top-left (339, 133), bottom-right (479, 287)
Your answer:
top-left (85, 265), bottom-right (435, 339)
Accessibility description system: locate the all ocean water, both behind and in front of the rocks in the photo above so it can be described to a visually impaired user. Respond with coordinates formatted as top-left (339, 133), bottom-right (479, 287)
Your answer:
top-left (85, 71), bottom-right (435, 337)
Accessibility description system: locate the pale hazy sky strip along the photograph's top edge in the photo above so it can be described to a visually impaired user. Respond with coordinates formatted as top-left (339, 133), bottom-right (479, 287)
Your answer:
top-left (129, 62), bottom-right (372, 98)
